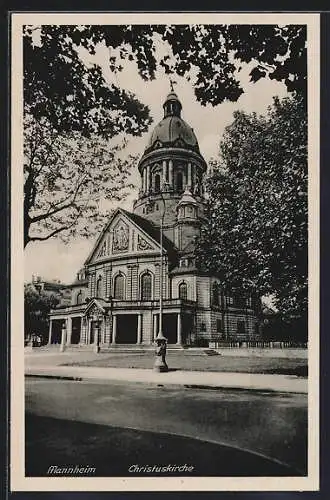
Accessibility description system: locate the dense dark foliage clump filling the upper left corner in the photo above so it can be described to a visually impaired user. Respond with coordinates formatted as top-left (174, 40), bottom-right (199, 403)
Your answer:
top-left (23, 25), bottom-right (151, 138)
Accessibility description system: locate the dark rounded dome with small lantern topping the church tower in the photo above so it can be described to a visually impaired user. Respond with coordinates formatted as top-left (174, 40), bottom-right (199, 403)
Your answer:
top-left (146, 92), bottom-right (198, 150)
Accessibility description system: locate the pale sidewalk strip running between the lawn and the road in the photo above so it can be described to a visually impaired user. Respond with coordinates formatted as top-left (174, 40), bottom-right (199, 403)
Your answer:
top-left (25, 365), bottom-right (308, 394)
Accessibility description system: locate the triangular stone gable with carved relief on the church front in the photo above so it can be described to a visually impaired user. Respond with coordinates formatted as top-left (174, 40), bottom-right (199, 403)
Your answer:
top-left (85, 208), bottom-right (160, 265)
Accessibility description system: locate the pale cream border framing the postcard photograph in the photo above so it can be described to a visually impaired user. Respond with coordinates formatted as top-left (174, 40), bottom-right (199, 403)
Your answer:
top-left (10, 12), bottom-right (320, 491)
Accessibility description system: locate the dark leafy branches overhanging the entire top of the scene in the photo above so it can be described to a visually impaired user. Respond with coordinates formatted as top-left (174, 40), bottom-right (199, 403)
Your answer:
top-left (24, 25), bottom-right (307, 137)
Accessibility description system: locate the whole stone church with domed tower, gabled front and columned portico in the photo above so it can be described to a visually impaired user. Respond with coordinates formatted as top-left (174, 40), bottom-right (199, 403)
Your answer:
top-left (49, 91), bottom-right (261, 349)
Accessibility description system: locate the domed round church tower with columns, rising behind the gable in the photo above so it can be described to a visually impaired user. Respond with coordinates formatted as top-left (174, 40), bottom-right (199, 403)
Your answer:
top-left (133, 91), bottom-right (207, 250)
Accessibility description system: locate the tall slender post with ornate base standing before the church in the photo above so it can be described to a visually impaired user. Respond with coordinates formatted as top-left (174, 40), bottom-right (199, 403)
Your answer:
top-left (154, 182), bottom-right (168, 372)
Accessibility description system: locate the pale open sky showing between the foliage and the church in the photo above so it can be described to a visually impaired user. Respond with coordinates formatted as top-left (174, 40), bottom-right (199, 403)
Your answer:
top-left (24, 33), bottom-right (287, 283)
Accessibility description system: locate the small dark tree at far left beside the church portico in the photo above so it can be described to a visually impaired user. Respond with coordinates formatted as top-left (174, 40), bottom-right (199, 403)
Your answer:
top-left (24, 284), bottom-right (60, 343)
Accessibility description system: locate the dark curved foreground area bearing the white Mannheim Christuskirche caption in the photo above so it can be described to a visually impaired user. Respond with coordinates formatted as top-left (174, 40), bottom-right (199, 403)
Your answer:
top-left (25, 415), bottom-right (300, 477)
